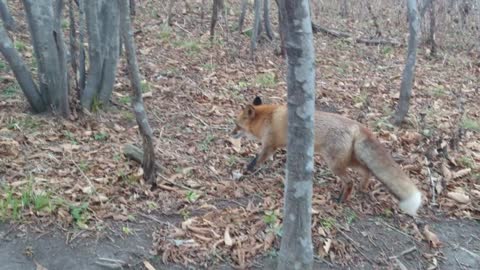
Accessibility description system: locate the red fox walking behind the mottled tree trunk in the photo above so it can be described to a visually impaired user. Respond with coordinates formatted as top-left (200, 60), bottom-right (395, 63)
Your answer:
top-left (232, 97), bottom-right (422, 216)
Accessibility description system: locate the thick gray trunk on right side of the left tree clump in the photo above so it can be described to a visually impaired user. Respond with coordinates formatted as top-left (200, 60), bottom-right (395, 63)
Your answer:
top-left (81, 0), bottom-right (120, 110)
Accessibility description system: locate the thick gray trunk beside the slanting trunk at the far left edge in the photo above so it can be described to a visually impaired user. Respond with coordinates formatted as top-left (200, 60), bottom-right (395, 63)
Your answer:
top-left (23, 0), bottom-right (70, 117)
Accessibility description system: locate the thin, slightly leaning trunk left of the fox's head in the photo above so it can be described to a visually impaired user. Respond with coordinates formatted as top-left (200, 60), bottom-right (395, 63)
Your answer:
top-left (120, 0), bottom-right (155, 185)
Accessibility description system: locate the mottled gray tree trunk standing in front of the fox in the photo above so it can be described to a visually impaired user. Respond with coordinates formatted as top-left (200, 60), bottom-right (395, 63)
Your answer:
top-left (277, 0), bottom-right (315, 270)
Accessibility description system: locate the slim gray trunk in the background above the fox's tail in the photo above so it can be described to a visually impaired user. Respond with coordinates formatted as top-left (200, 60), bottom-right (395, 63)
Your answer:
top-left (393, 0), bottom-right (420, 125)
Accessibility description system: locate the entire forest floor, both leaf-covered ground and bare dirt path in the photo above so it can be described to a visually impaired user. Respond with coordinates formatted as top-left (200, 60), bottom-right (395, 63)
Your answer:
top-left (0, 1), bottom-right (480, 270)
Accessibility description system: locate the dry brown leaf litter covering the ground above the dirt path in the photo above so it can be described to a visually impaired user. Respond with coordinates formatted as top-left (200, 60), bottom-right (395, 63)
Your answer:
top-left (0, 0), bottom-right (480, 268)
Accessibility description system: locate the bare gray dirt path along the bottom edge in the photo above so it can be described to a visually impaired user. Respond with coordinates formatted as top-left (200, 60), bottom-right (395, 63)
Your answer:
top-left (0, 218), bottom-right (480, 270)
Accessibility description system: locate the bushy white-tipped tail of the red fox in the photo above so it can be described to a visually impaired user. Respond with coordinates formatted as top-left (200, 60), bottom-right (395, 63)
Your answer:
top-left (353, 130), bottom-right (422, 216)
